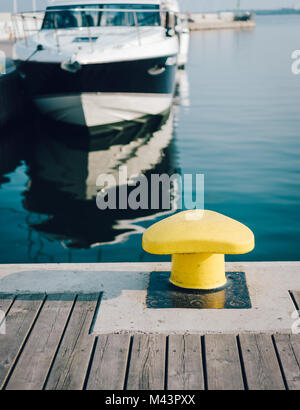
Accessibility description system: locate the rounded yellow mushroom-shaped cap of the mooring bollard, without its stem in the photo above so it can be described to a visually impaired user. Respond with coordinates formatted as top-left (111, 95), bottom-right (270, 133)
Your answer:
top-left (143, 210), bottom-right (254, 255)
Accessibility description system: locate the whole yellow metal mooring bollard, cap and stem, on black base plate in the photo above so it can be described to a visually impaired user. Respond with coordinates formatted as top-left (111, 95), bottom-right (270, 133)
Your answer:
top-left (143, 210), bottom-right (254, 290)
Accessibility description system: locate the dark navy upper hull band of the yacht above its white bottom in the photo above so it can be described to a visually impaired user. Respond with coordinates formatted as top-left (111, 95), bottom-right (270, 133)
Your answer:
top-left (19, 56), bottom-right (177, 96)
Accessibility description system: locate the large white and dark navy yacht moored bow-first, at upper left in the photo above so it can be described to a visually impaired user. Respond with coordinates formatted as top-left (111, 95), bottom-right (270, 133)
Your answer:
top-left (14, 0), bottom-right (189, 129)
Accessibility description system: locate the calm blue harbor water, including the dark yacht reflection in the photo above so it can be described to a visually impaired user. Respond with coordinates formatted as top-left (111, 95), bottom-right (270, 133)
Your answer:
top-left (0, 16), bottom-right (300, 263)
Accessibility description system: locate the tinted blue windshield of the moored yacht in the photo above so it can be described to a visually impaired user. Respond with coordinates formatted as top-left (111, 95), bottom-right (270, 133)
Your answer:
top-left (42, 4), bottom-right (161, 30)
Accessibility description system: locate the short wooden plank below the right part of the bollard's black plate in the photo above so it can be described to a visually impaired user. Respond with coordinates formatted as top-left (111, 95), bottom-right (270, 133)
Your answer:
top-left (204, 334), bottom-right (244, 390)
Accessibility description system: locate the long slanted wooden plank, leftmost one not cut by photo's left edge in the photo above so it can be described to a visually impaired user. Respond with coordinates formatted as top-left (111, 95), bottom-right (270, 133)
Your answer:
top-left (6, 294), bottom-right (75, 390)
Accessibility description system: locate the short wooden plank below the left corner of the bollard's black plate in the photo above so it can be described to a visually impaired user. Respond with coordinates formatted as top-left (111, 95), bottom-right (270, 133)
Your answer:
top-left (126, 334), bottom-right (166, 390)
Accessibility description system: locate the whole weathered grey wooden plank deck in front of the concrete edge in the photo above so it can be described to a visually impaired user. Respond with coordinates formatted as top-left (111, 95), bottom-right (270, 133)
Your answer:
top-left (0, 292), bottom-right (300, 390)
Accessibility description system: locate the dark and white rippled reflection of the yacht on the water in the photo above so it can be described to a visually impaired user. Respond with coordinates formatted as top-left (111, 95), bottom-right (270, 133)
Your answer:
top-left (23, 109), bottom-right (178, 248)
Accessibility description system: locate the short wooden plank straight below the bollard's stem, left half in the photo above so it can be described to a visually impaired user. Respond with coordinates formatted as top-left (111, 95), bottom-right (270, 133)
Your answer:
top-left (167, 335), bottom-right (204, 390)
